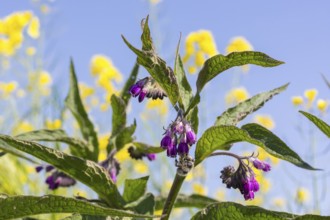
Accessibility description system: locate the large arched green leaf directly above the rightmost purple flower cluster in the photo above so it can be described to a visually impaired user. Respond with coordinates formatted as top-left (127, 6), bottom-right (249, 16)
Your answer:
top-left (195, 123), bottom-right (315, 170)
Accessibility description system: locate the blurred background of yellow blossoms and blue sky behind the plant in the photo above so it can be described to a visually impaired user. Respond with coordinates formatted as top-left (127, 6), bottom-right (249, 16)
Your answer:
top-left (0, 0), bottom-right (330, 216)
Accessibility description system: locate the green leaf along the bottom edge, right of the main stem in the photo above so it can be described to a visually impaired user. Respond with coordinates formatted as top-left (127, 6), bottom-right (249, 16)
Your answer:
top-left (192, 202), bottom-right (329, 220)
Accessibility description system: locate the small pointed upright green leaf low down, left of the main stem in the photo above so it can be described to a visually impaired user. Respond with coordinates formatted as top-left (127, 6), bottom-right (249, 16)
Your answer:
top-left (123, 176), bottom-right (149, 203)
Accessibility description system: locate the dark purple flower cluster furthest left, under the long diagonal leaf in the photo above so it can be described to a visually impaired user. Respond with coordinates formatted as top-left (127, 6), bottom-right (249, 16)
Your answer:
top-left (35, 165), bottom-right (76, 190)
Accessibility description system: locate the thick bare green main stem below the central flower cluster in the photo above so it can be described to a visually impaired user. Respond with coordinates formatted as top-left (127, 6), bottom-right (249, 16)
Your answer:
top-left (160, 173), bottom-right (186, 220)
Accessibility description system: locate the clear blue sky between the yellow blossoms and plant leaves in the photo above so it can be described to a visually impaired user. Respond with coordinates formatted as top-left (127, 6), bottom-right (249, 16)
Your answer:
top-left (0, 0), bottom-right (330, 214)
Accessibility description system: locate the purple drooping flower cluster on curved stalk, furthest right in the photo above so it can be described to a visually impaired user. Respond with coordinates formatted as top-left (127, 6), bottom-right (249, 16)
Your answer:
top-left (220, 156), bottom-right (270, 200)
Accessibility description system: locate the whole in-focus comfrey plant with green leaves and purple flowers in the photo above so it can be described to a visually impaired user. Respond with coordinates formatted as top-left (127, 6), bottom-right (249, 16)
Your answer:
top-left (0, 17), bottom-right (321, 219)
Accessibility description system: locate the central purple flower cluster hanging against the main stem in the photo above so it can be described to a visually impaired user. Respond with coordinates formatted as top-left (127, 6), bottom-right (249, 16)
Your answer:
top-left (160, 116), bottom-right (196, 157)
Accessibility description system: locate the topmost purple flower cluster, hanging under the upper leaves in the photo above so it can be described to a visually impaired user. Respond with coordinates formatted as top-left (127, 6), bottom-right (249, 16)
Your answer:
top-left (129, 77), bottom-right (166, 102)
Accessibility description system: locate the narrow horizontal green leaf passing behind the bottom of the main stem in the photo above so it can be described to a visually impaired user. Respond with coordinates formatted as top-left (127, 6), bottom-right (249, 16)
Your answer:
top-left (155, 194), bottom-right (219, 210)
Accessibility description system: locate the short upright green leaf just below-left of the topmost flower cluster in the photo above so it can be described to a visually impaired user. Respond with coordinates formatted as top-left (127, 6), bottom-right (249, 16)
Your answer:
top-left (111, 94), bottom-right (126, 136)
